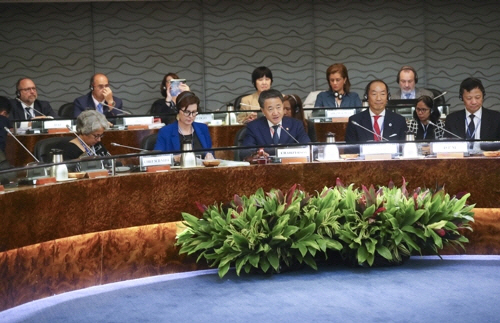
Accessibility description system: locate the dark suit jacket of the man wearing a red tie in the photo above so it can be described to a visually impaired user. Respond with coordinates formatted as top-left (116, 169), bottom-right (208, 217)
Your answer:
top-left (345, 109), bottom-right (408, 143)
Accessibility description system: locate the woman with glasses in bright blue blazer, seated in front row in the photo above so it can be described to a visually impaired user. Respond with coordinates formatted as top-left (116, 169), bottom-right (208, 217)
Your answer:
top-left (155, 91), bottom-right (214, 162)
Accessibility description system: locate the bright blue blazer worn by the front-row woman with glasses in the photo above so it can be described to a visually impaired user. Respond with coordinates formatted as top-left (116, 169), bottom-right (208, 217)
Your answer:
top-left (155, 120), bottom-right (213, 154)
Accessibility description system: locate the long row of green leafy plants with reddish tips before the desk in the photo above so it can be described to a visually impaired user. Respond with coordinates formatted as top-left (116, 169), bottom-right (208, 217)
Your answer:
top-left (177, 179), bottom-right (474, 277)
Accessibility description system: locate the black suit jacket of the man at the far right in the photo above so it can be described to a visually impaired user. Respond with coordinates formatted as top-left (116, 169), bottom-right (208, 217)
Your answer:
top-left (444, 107), bottom-right (500, 140)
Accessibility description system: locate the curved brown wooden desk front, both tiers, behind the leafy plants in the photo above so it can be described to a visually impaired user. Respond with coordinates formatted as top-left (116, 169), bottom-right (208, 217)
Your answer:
top-left (0, 158), bottom-right (500, 310)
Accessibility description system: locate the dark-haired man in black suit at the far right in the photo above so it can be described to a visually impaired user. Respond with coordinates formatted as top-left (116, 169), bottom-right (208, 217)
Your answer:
top-left (445, 77), bottom-right (500, 140)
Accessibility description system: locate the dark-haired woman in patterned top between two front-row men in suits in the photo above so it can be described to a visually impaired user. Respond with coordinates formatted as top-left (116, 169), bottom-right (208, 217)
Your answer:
top-left (407, 95), bottom-right (444, 140)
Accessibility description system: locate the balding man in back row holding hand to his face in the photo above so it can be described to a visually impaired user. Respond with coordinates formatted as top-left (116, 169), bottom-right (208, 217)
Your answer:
top-left (73, 73), bottom-right (123, 118)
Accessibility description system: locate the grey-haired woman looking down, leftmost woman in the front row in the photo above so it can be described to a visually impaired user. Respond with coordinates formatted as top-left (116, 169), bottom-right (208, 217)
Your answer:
top-left (61, 110), bottom-right (109, 160)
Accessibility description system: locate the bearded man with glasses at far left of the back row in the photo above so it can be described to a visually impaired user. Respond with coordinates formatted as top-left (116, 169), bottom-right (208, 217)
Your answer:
top-left (10, 78), bottom-right (57, 120)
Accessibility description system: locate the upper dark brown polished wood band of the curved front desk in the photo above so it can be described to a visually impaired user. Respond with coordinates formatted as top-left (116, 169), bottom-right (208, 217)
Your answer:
top-left (0, 157), bottom-right (500, 251)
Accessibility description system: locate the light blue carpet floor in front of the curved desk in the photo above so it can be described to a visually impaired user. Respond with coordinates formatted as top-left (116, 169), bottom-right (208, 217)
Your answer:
top-left (0, 256), bottom-right (500, 323)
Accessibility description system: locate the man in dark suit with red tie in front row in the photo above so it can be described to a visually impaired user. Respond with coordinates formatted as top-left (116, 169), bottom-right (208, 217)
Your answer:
top-left (345, 80), bottom-right (408, 143)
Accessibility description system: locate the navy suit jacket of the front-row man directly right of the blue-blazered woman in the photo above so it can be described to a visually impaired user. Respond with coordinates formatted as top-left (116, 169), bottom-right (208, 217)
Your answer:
top-left (240, 117), bottom-right (311, 158)
